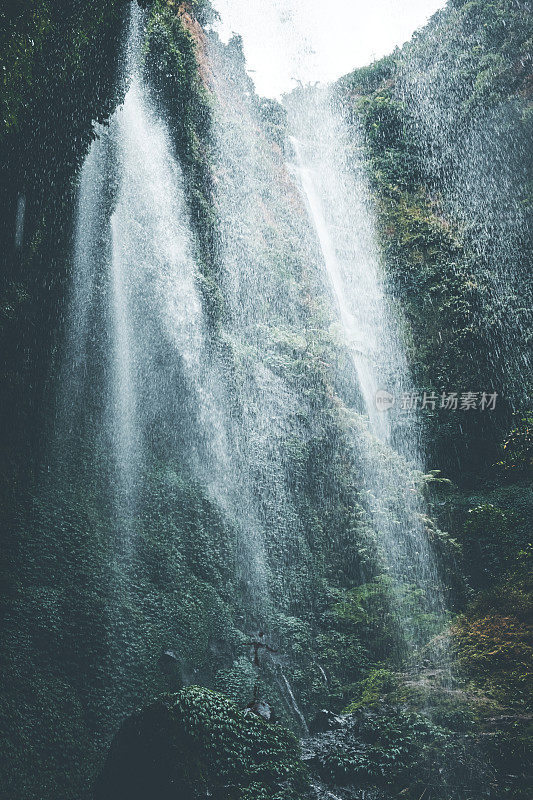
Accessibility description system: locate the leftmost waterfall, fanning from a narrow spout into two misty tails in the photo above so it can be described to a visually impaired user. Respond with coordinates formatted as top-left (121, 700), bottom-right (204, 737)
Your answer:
top-left (60, 4), bottom-right (267, 612)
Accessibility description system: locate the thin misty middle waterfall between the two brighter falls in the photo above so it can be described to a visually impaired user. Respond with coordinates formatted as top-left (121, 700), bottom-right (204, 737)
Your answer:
top-left (204, 32), bottom-right (320, 609)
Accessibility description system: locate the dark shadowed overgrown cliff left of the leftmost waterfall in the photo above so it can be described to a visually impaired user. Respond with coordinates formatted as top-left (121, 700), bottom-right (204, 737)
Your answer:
top-left (0, 0), bottom-right (129, 494)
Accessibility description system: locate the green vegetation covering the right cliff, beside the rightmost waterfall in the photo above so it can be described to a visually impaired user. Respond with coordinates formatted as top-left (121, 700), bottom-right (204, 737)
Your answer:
top-left (337, 0), bottom-right (533, 798)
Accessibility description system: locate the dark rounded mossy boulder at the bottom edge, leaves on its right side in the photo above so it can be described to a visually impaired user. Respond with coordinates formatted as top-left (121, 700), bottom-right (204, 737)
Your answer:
top-left (94, 687), bottom-right (308, 800)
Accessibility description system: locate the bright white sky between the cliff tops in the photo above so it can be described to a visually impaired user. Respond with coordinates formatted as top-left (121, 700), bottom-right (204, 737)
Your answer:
top-left (212, 0), bottom-right (445, 97)
